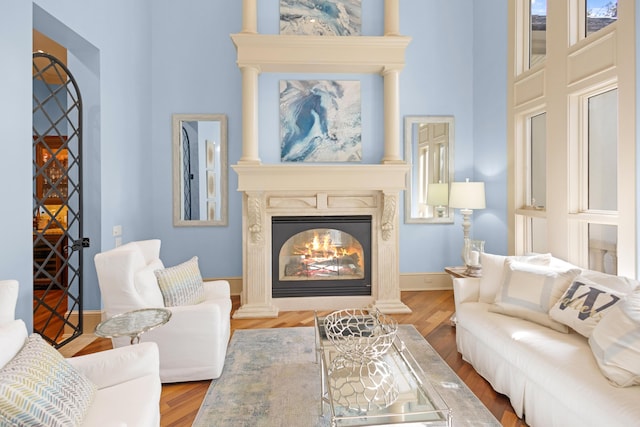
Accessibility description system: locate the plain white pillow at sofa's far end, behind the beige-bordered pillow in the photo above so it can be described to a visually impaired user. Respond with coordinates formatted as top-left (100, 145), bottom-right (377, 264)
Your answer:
top-left (478, 253), bottom-right (551, 304)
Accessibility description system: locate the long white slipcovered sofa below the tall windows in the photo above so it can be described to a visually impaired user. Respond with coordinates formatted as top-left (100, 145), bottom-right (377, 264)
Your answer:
top-left (453, 255), bottom-right (640, 427)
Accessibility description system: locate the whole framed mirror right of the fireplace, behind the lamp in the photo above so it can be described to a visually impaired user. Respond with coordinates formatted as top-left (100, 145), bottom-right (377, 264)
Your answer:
top-left (404, 116), bottom-right (455, 224)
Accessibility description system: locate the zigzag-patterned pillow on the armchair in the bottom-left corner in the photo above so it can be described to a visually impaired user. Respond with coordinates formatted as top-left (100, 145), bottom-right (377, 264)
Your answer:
top-left (0, 334), bottom-right (96, 427)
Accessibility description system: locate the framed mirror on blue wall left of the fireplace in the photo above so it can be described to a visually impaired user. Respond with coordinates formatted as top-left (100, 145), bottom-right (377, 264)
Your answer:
top-left (172, 114), bottom-right (228, 227)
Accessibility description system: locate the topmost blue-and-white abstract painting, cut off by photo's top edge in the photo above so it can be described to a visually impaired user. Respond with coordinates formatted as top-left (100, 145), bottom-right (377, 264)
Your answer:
top-left (280, 0), bottom-right (362, 36)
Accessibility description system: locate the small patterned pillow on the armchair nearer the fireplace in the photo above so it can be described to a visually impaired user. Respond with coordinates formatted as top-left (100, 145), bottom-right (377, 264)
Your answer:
top-left (155, 256), bottom-right (204, 307)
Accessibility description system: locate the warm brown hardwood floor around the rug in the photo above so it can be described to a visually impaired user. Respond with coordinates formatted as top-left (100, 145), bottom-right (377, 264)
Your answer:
top-left (76, 290), bottom-right (526, 427)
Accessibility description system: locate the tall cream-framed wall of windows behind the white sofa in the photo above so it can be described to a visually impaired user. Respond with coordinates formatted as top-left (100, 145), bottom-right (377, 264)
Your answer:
top-left (507, 0), bottom-right (640, 277)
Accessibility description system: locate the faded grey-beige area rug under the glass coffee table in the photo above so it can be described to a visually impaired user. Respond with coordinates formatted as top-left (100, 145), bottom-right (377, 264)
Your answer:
top-left (193, 325), bottom-right (500, 427)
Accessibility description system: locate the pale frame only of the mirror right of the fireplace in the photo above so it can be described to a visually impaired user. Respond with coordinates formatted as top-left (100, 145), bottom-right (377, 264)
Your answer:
top-left (404, 116), bottom-right (455, 224)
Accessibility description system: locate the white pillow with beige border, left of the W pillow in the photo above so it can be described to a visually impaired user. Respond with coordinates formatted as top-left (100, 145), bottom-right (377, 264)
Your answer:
top-left (489, 259), bottom-right (580, 333)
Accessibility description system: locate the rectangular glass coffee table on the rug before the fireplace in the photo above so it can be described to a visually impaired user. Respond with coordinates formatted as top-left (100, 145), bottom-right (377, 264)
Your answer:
top-left (315, 314), bottom-right (452, 427)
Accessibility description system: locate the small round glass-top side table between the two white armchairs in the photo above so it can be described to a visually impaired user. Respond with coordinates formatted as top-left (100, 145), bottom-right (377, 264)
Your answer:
top-left (95, 308), bottom-right (171, 344)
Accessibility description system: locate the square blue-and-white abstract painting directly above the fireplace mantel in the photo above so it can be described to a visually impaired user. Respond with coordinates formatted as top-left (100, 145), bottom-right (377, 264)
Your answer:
top-left (280, 80), bottom-right (362, 162)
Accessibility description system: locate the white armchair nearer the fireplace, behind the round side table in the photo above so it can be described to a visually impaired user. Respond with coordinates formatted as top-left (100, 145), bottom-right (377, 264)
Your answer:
top-left (94, 239), bottom-right (231, 383)
